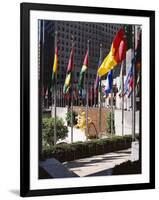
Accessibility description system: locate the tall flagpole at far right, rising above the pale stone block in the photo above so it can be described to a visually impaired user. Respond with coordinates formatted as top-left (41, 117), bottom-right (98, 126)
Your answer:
top-left (132, 26), bottom-right (136, 141)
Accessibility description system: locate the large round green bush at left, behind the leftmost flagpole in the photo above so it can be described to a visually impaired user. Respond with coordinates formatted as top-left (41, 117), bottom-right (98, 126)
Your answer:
top-left (42, 117), bottom-right (68, 149)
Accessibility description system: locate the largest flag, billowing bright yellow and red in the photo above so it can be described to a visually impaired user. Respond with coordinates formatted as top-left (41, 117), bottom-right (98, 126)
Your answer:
top-left (98, 28), bottom-right (126, 77)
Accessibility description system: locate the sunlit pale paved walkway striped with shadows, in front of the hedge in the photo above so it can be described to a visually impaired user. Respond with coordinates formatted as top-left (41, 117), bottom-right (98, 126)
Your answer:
top-left (63, 149), bottom-right (131, 177)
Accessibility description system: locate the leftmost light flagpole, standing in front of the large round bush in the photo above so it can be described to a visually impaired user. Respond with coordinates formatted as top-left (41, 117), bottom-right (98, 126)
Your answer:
top-left (52, 31), bottom-right (57, 145)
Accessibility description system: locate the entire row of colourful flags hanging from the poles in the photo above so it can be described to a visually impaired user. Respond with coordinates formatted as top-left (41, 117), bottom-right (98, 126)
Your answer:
top-left (47, 28), bottom-right (141, 100)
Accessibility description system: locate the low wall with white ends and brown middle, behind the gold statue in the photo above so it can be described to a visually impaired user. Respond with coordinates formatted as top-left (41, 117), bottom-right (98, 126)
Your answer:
top-left (52, 106), bottom-right (139, 136)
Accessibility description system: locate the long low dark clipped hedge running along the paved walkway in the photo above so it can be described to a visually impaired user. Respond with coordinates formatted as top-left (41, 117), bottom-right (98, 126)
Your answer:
top-left (42, 136), bottom-right (137, 162)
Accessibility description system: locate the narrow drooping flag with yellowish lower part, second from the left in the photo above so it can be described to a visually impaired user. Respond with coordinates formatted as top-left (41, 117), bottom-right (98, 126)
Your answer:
top-left (63, 48), bottom-right (74, 94)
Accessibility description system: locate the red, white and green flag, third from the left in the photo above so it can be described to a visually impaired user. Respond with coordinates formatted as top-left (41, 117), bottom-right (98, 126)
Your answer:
top-left (78, 50), bottom-right (88, 91)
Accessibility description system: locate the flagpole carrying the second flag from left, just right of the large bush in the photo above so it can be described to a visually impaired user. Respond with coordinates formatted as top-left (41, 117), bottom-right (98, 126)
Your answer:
top-left (71, 35), bottom-right (74, 143)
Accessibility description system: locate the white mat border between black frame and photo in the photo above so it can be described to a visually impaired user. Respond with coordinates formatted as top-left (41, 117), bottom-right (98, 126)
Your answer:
top-left (30, 11), bottom-right (150, 190)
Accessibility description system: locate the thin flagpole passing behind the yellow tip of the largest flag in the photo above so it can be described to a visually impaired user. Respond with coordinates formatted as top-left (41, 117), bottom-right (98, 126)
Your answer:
top-left (99, 44), bottom-right (102, 137)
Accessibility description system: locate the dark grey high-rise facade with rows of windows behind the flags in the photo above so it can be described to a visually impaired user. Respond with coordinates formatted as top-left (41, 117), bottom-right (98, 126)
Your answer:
top-left (41, 20), bottom-right (125, 87)
